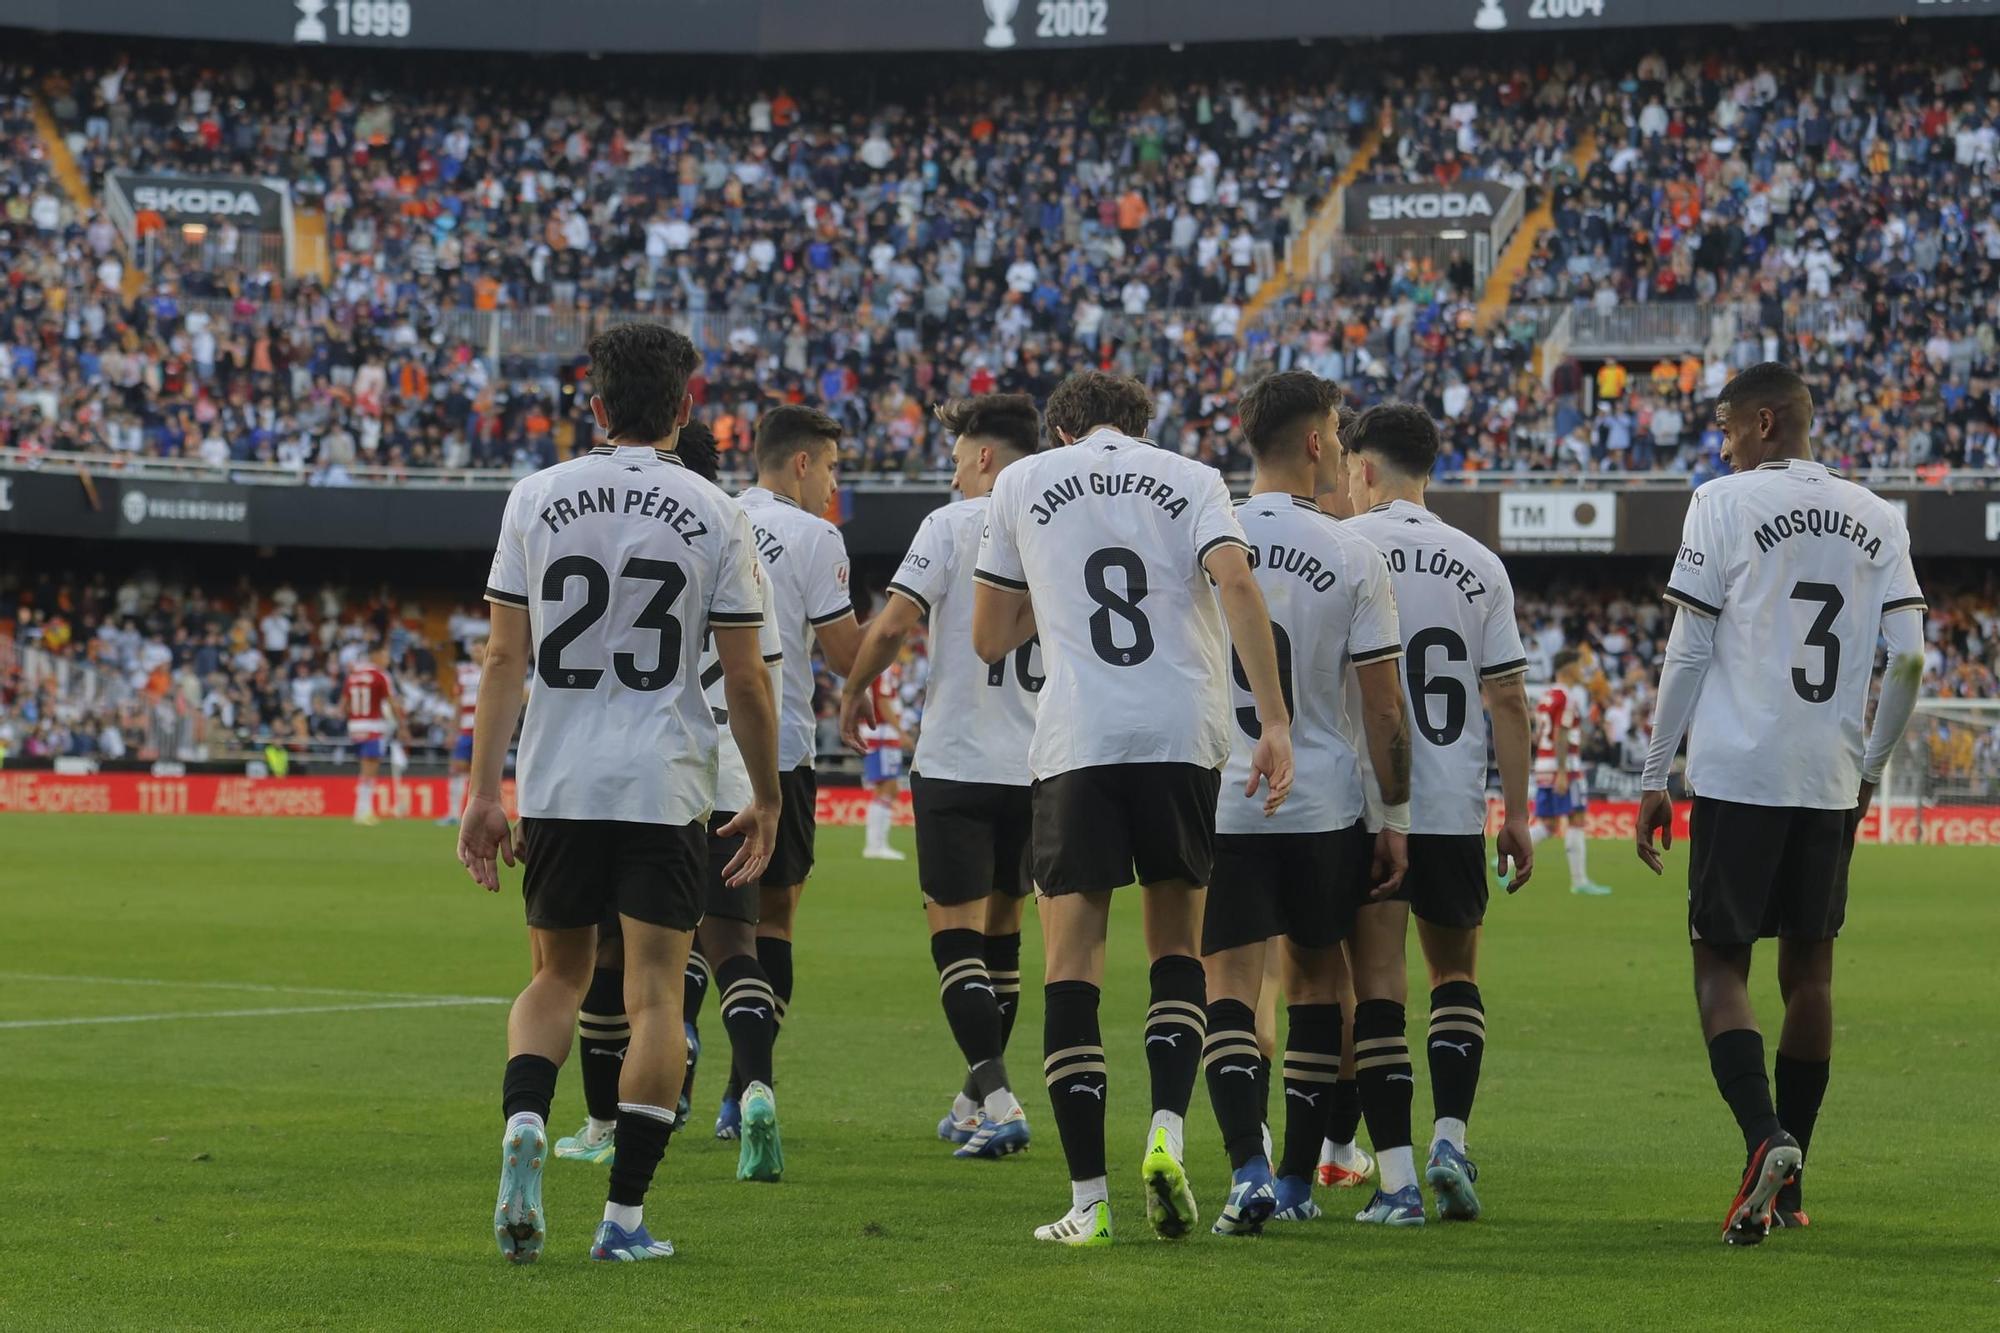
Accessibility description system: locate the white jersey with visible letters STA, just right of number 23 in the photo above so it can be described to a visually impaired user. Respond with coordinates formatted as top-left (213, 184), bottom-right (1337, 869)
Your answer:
top-left (738, 486), bottom-right (854, 773)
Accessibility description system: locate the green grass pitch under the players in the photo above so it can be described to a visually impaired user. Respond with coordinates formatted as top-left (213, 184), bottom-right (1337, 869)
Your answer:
top-left (0, 815), bottom-right (2000, 1333)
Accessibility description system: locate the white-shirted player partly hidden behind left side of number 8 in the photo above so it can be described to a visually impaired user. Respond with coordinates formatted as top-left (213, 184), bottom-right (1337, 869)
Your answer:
top-left (840, 394), bottom-right (1042, 1157)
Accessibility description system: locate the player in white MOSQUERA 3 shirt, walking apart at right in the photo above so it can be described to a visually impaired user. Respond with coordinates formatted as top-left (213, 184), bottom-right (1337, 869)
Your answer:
top-left (1638, 362), bottom-right (1924, 1245)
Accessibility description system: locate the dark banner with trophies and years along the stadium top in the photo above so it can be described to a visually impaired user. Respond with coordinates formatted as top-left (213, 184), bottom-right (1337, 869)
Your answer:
top-left (0, 0), bottom-right (1994, 54)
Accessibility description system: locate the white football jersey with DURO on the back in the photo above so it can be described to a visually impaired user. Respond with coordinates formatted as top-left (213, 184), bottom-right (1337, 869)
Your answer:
top-left (1216, 492), bottom-right (1402, 833)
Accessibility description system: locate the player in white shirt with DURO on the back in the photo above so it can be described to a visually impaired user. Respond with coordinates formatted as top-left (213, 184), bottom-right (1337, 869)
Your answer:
top-left (1202, 370), bottom-right (1410, 1235)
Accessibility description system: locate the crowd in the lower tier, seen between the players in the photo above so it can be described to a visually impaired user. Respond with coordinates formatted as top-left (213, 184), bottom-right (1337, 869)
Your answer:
top-left (0, 566), bottom-right (2000, 793)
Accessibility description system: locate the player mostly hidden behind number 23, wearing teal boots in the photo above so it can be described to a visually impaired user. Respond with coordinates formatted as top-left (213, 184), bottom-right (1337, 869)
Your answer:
top-left (556, 420), bottom-right (784, 1181)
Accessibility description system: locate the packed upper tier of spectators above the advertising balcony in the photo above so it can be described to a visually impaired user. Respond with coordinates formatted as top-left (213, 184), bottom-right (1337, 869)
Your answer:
top-left (0, 22), bottom-right (2000, 480)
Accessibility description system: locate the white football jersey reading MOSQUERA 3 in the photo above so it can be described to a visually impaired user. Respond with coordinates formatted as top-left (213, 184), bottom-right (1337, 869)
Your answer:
top-left (1666, 458), bottom-right (1924, 811)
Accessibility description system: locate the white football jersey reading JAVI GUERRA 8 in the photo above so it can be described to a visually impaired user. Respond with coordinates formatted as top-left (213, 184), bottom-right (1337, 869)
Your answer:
top-left (974, 430), bottom-right (1248, 779)
